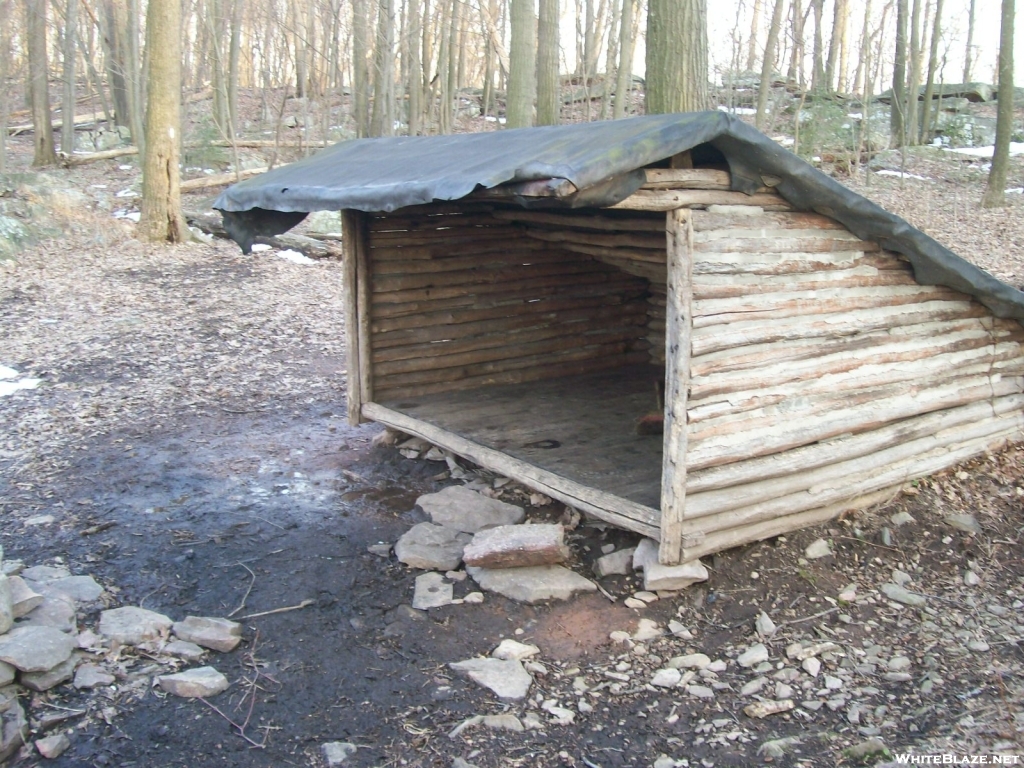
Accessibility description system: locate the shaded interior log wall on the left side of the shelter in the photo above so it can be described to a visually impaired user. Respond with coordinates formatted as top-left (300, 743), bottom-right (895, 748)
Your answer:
top-left (367, 206), bottom-right (651, 402)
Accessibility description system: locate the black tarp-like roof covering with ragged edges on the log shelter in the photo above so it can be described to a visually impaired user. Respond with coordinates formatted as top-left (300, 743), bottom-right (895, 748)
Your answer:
top-left (214, 112), bottom-right (1024, 321)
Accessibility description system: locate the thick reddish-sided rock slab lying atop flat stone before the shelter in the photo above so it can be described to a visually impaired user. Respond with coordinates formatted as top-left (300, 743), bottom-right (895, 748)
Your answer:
top-left (462, 523), bottom-right (569, 568)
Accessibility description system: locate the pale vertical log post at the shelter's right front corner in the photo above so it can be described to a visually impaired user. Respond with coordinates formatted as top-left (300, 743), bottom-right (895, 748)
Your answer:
top-left (658, 208), bottom-right (693, 565)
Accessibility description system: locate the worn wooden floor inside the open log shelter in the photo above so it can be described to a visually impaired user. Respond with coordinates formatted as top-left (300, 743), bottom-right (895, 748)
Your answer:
top-left (381, 365), bottom-right (665, 509)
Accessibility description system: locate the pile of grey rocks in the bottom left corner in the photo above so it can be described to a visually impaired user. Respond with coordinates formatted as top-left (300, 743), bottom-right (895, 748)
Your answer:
top-left (0, 550), bottom-right (242, 762)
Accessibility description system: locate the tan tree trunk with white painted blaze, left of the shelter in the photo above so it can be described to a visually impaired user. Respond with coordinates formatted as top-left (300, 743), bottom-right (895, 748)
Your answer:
top-left (138, 0), bottom-right (188, 243)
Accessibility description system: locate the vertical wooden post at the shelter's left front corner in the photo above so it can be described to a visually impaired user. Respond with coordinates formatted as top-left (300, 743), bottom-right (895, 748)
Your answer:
top-left (341, 211), bottom-right (372, 426)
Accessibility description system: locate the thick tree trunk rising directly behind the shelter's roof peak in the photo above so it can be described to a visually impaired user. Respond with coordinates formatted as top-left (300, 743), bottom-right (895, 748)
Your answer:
top-left (646, 0), bottom-right (709, 115)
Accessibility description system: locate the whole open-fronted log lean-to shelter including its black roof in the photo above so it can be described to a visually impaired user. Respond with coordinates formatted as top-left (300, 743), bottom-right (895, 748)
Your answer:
top-left (215, 113), bottom-right (1024, 564)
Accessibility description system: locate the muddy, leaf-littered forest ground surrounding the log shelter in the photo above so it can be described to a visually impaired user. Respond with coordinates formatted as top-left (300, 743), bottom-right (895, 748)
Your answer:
top-left (0, 114), bottom-right (1024, 768)
